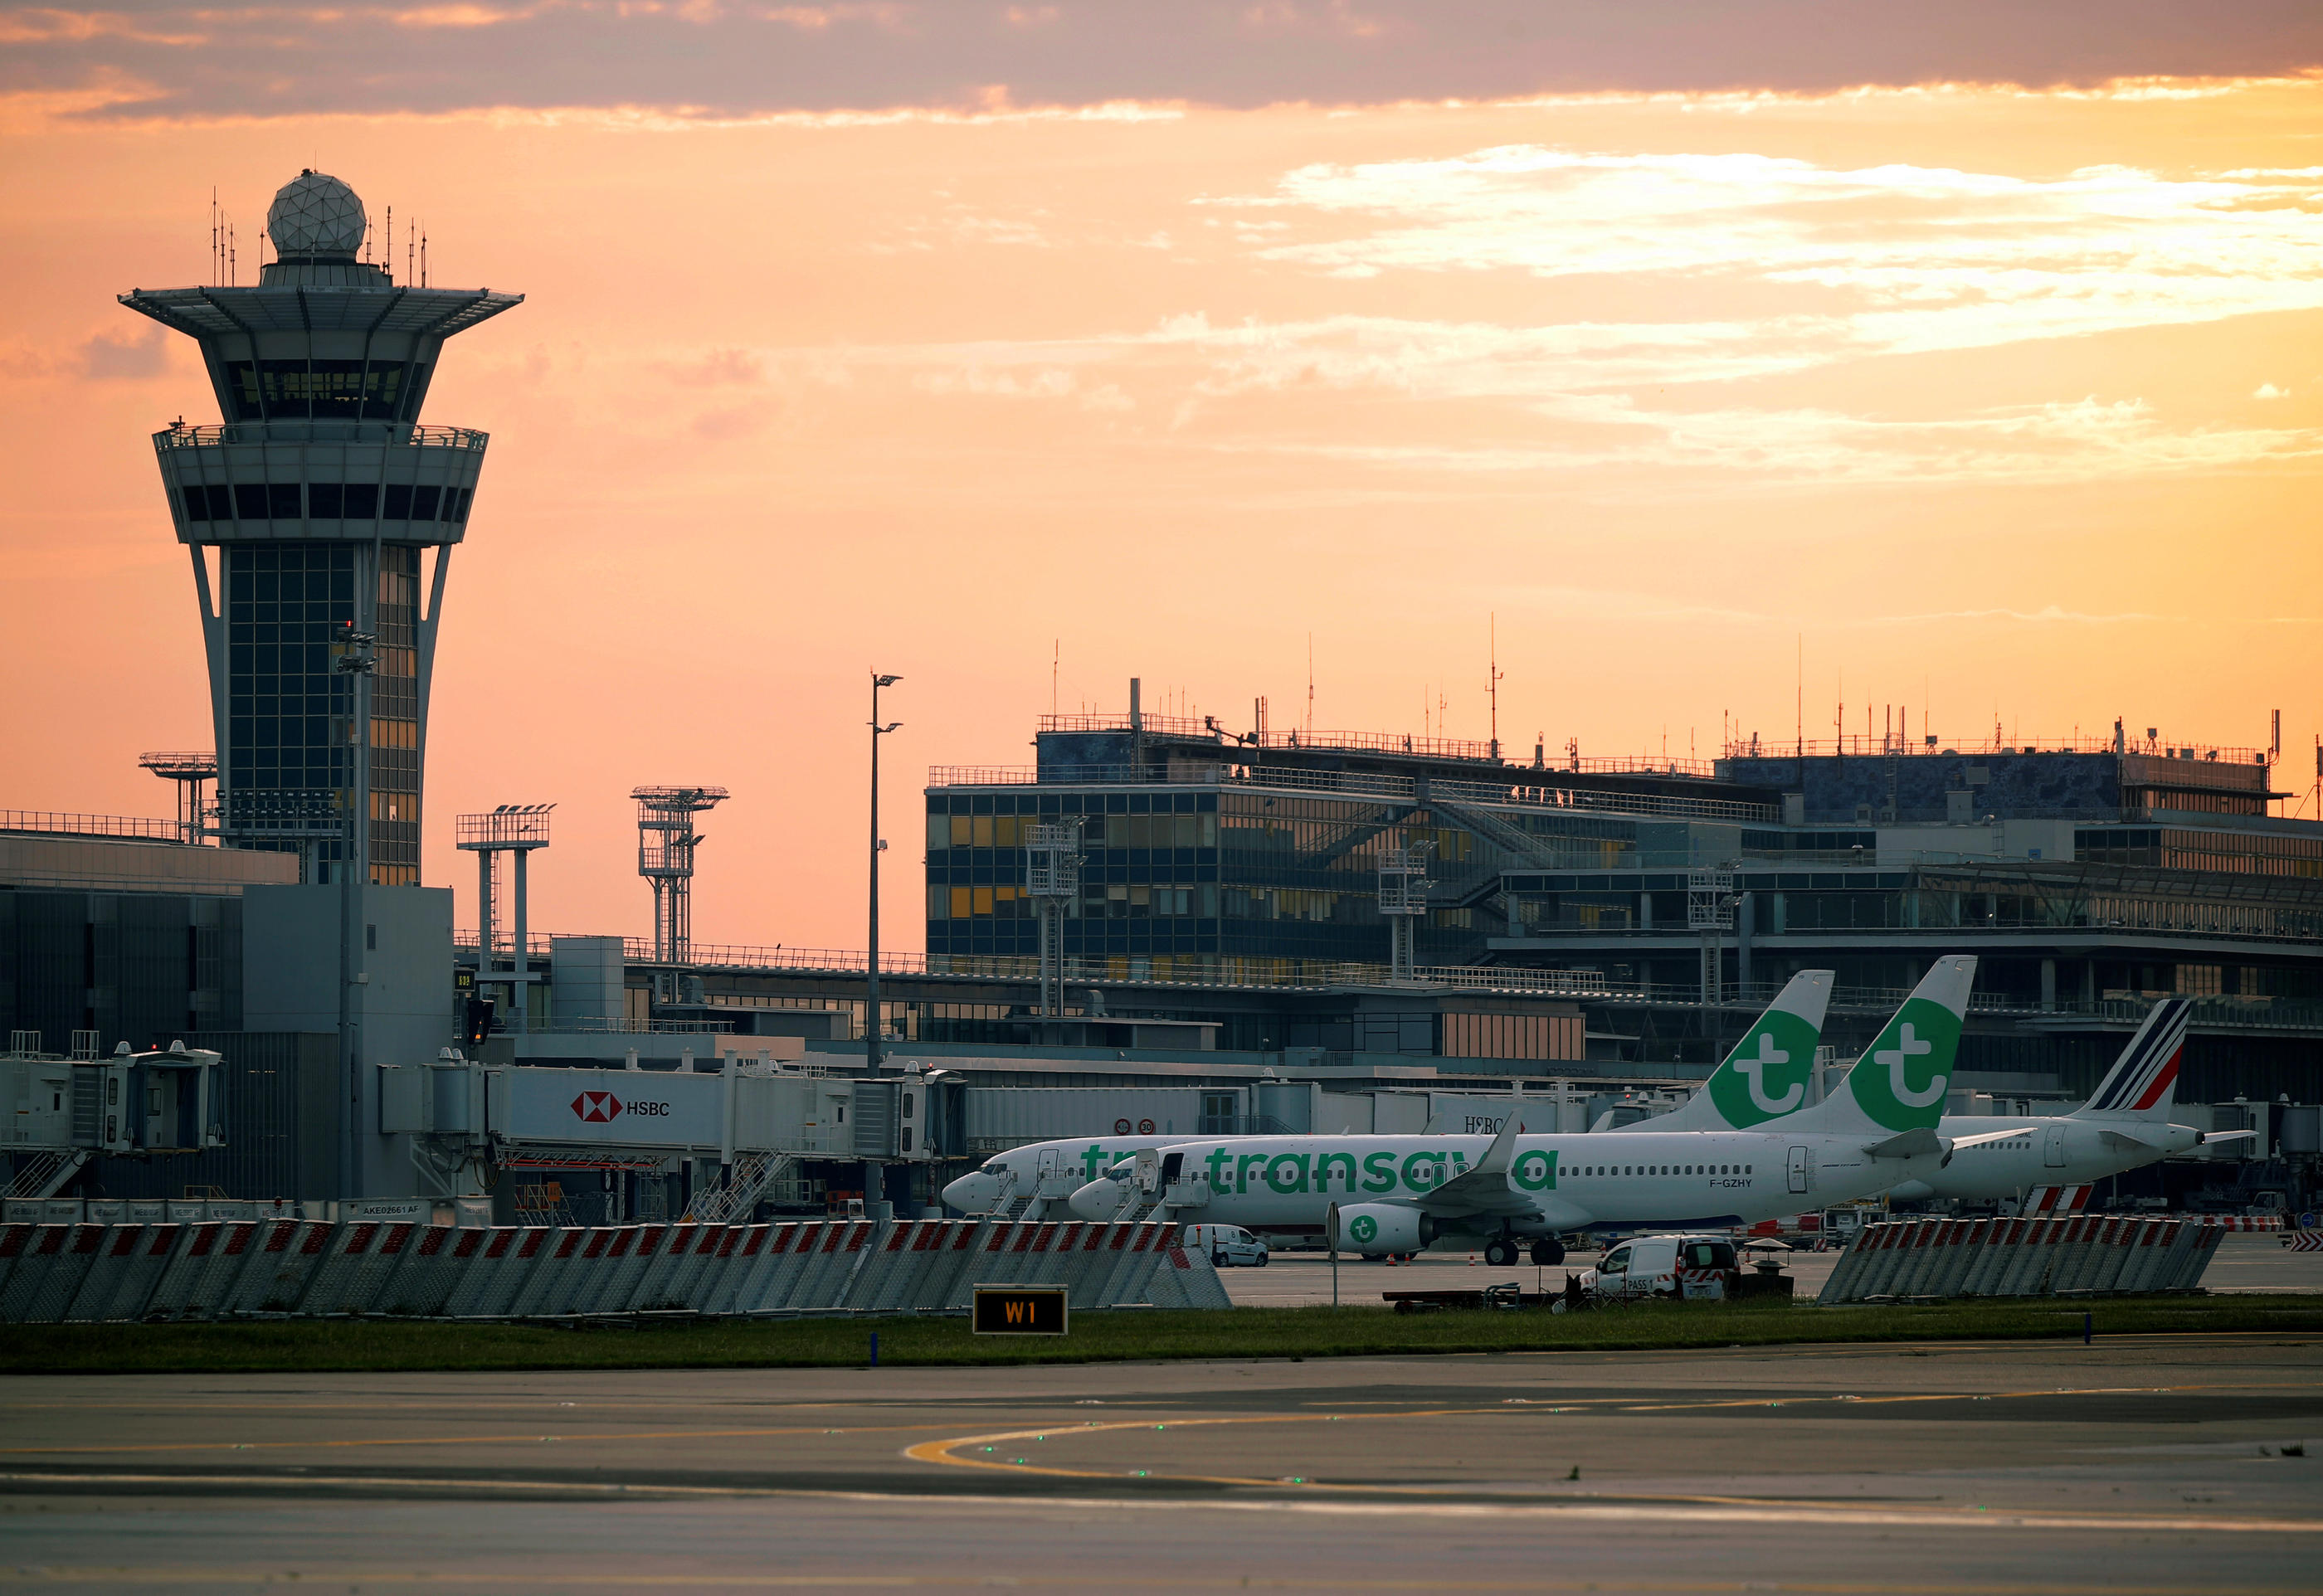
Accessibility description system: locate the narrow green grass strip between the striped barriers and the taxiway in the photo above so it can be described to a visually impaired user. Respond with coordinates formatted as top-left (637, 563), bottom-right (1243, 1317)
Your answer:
top-left (13, 1297), bottom-right (2323, 1373)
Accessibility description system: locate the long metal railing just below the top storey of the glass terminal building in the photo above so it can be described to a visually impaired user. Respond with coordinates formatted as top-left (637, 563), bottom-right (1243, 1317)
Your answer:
top-left (927, 762), bottom-right (1782, 825)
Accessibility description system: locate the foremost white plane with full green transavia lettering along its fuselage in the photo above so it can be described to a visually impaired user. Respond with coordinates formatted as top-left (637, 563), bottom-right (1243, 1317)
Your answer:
top-left (1074, 955), bottom-right (2019, 1266)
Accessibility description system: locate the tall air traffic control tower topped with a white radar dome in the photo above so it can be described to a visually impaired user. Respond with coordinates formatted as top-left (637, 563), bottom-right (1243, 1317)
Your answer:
top-left (121, 172), bottom-right (523, 885)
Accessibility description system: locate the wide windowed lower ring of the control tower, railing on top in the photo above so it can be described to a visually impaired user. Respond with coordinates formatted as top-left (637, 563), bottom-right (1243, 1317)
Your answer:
top-left (153, 421), bottom-right (485, 543)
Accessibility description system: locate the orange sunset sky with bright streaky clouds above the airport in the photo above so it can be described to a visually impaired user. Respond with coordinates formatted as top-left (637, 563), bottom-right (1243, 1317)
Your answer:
top-left (0, 0), bottom-right (2323, 948)
